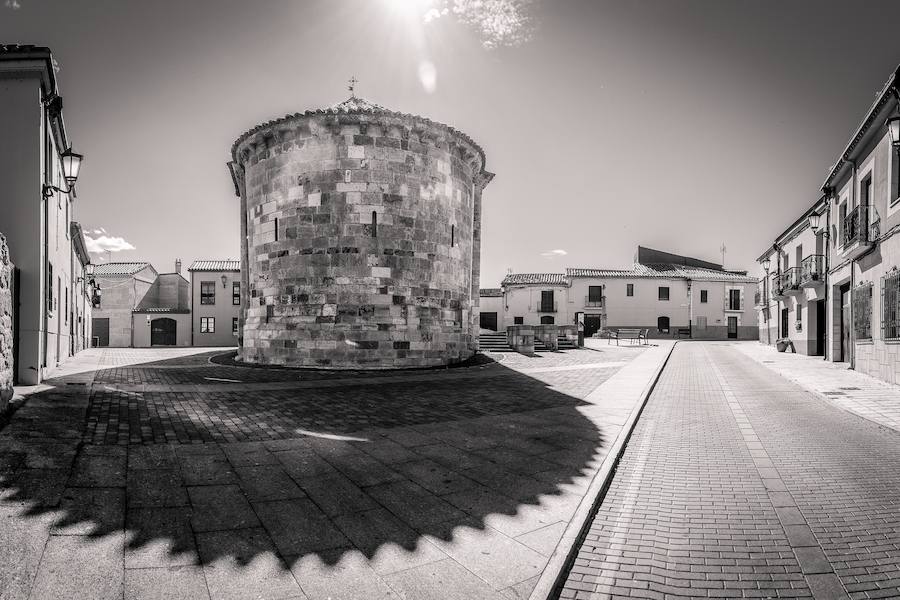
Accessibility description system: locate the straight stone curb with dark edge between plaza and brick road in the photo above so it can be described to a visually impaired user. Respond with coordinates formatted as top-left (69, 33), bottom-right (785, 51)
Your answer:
top-left (528, 340), bottom-right (678, 600)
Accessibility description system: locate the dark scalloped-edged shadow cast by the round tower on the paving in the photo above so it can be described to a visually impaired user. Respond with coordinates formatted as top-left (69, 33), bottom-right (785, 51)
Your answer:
top-left (0, 356), bottom-right (605, 566)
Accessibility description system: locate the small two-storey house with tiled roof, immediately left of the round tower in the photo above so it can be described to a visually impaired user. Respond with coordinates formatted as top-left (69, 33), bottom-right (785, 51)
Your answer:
top-left (188, 260), bottom-right (241, 347)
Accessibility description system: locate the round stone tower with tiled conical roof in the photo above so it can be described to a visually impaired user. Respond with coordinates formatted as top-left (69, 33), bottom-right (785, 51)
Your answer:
top-left (229, 96), bottom-right (493, 369)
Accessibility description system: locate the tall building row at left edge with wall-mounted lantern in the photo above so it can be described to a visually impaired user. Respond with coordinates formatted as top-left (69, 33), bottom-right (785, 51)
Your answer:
top-left (0, 46), bottom-right (93, 384)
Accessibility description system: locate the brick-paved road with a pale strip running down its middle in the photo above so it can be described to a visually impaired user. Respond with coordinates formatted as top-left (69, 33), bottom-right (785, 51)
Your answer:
top-left (560, 342), bottom-right (900, 599)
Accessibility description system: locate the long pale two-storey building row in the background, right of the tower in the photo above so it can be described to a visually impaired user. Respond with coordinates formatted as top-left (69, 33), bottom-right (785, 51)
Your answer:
top-left (481, 247), bottom-right (759, 340)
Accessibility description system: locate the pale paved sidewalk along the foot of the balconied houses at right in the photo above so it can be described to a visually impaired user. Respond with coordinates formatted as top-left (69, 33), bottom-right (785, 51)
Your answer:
top-left (735, 343), bottom-right (900, 431)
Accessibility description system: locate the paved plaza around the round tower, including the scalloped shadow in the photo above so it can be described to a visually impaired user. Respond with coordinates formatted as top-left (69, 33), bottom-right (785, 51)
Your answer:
top-left (0, 347), bottom-right (667, 600)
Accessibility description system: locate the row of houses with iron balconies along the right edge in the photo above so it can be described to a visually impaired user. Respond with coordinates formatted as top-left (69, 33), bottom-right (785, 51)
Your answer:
top-left (760, 69), bottom-right (900, 383)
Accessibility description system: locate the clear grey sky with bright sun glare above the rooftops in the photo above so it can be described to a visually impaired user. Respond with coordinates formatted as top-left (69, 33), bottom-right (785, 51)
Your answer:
top-left (0, 0), bottom-right (900, 287)
